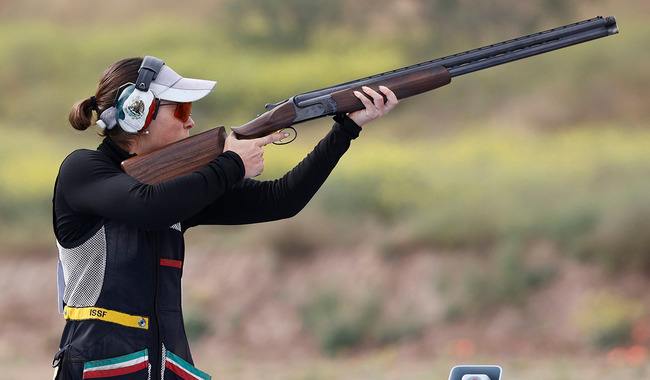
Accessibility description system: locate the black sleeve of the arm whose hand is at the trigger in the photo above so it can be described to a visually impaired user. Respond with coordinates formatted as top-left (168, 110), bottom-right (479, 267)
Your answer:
top-left (57, 150), bottom-right (244, 229)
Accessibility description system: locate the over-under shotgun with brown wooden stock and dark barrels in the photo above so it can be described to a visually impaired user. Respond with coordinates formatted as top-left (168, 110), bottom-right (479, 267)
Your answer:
top-left (122, 16), bottom-right (618, 184)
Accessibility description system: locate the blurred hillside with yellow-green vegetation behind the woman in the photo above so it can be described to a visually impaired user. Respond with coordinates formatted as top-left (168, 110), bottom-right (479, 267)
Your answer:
top-left (0, 0), bottom-right (650, 379)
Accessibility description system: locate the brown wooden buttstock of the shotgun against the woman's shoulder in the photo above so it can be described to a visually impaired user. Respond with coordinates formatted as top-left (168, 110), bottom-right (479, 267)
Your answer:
top-left (121, 126), bottom-right (227, 185)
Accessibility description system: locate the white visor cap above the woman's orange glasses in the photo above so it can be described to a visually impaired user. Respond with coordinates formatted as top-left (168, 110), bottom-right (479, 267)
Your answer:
top-left (149, 65), bottom-right (217, 103)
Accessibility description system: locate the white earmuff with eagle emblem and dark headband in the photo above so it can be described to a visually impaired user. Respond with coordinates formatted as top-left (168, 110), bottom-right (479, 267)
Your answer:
top-left (115, 56), bottom-right (165, 133)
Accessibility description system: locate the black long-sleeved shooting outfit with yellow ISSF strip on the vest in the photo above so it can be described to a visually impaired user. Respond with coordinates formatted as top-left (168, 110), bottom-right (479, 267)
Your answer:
top-left (53, 116), bottom-right (361, 379)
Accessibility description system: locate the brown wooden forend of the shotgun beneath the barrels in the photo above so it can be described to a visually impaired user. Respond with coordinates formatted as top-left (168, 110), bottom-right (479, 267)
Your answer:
top-left (332, 66), bottom-right (451, 112)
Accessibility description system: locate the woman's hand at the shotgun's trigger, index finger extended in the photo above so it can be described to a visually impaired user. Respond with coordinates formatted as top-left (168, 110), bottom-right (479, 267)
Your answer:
top-left (223, 132), bottom-right (289, 178)
